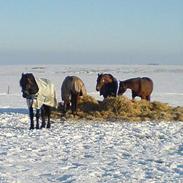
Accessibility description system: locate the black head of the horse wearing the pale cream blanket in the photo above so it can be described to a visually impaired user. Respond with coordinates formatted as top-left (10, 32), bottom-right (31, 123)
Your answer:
top-left (20, 73), bottom-right (39, 99)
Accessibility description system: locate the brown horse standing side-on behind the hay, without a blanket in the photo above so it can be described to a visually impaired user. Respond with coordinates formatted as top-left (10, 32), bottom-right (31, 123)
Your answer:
top-left (118, 77), bottom-right (153, 101)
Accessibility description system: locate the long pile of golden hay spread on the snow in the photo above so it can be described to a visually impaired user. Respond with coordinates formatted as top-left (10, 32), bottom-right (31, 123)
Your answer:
top-left (53, 96), bottom-right (183, 121)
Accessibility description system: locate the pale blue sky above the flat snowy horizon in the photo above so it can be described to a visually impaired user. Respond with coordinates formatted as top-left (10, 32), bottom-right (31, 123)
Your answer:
top-left (0, 0), bottom-right (183, 64)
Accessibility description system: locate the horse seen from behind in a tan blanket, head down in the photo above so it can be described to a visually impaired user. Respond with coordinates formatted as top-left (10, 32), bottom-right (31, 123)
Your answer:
top-left (61, 76), bottom-right (87, 114)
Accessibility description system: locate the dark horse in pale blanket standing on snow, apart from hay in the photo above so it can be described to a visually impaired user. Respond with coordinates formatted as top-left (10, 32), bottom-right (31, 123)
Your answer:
top-left (20, 73), bottom-right (57, 130)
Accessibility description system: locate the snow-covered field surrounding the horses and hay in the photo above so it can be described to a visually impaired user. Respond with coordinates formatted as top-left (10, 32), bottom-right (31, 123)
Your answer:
top-left (0, 65), bottom-right (183, 183)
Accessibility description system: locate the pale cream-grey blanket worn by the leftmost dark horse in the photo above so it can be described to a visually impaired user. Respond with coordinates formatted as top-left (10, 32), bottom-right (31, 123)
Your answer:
top-left (27, 78), bottom-right (57, 109)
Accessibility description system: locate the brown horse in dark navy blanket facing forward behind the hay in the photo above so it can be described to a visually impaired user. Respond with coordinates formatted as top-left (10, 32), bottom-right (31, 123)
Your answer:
top-left (96, 74), bottom-right (118, 98)
